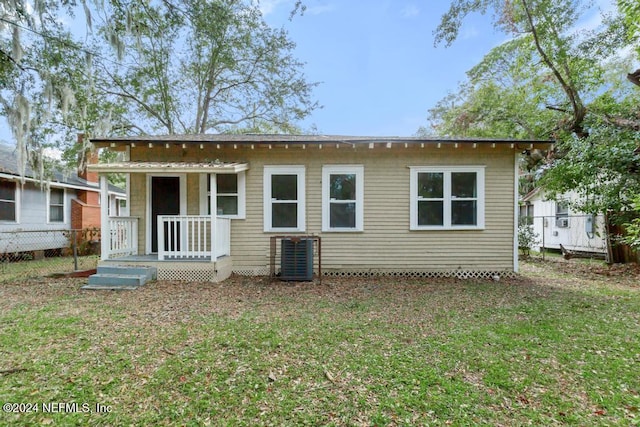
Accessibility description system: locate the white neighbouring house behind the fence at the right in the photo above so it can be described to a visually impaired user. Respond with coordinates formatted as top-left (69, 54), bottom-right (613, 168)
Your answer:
top-left (520, 188), bottom-right (607, 254)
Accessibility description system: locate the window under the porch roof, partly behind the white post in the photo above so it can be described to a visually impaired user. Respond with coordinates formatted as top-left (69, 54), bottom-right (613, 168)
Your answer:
top-left (200, 172), bottom-right (245, 219)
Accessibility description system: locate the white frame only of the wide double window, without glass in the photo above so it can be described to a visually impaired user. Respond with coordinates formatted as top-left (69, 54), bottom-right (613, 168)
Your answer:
top-left (409, 166), bottom-right (485, 230)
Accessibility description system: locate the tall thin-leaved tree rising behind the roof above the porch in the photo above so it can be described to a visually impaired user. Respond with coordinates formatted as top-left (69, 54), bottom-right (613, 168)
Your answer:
top-left (93, 0), bottom-right (318, 134)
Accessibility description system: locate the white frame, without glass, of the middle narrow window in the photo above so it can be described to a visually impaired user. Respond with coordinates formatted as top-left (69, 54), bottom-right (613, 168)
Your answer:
top-left (322, 165), bottom-right (364, 232)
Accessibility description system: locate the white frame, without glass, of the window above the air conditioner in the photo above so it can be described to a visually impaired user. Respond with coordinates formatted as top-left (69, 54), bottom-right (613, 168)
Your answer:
top-left (263, 165), bottom-right (306, 233)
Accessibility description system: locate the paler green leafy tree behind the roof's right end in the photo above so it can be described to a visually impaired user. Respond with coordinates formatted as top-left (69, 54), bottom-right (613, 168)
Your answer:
top-left (429, 38), bottom-right (555, 139)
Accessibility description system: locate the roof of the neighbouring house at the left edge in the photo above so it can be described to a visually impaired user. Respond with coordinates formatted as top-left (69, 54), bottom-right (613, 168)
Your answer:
top-left (0, 143), bottom-right (125, 195)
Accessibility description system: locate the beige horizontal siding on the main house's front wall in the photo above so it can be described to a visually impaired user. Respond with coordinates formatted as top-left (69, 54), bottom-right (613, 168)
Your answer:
top-left (131, 145), bottom-right (515, 271)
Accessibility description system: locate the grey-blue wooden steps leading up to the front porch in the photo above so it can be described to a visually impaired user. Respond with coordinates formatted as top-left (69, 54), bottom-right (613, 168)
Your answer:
top-left (82, 266), bottom-right (157, 290)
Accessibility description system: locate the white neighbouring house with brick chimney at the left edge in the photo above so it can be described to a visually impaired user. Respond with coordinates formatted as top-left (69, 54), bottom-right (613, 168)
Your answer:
top-left (0, 144), bottom-right (126, 254)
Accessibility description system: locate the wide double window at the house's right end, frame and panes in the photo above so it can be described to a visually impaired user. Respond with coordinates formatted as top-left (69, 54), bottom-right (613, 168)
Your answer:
top-left (410, 166), bottom-right (484, 230)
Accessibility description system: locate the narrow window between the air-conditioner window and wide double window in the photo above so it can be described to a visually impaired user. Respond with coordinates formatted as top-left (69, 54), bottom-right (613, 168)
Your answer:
top-left (322, 165), bottom-right (364, 231)
